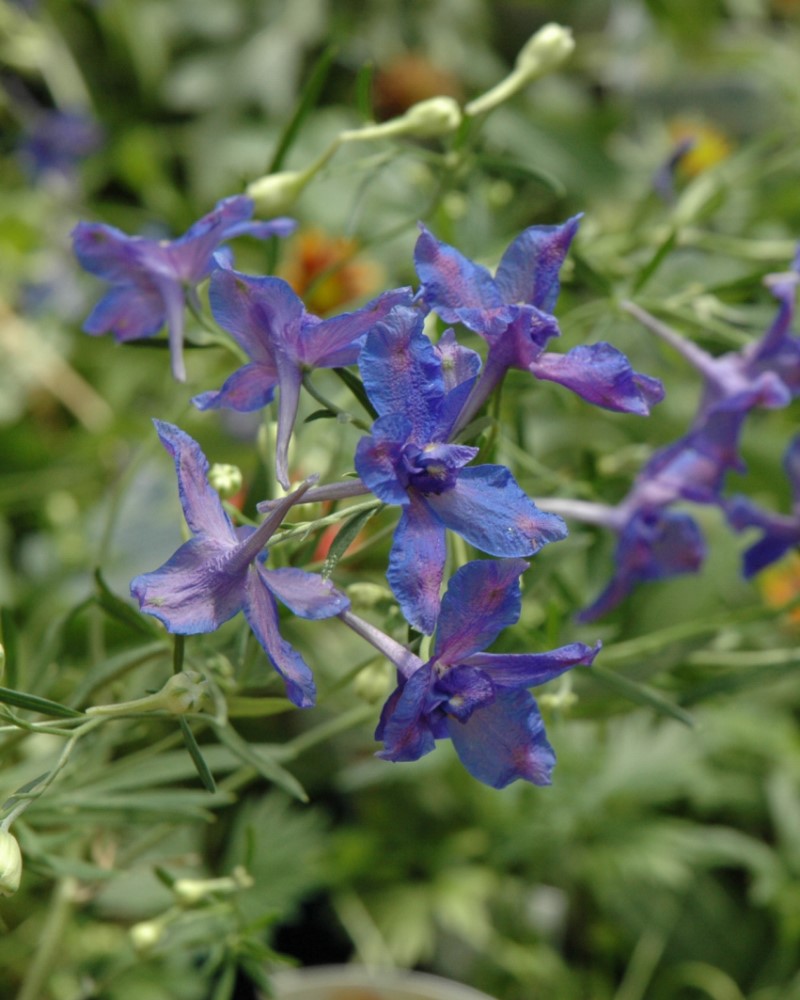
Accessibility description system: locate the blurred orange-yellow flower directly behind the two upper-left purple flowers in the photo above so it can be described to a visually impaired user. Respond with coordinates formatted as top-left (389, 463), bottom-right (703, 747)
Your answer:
top-left (280, 229), bottom-right (383, 316)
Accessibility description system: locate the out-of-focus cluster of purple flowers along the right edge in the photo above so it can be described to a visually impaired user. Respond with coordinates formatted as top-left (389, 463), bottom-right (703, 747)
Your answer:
top-left (545, 253), bottom-right (800, 621)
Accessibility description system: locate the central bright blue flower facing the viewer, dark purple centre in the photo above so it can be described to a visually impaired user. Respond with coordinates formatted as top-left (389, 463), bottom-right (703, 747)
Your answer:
top-left (355, 307), bottom-right (566, 633)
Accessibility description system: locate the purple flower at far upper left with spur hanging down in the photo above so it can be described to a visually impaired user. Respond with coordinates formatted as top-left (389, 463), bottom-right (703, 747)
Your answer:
top-left (72, 195), bottom-right (296, 381)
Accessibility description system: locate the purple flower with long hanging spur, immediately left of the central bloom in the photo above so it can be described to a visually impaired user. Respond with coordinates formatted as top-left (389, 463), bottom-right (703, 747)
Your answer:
top-left (193, 268), bottom-right (410, 487)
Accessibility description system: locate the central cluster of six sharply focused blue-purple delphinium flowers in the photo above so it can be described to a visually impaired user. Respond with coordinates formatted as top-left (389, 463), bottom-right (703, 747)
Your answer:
top-left (74, 197), bottom-right (664, 788)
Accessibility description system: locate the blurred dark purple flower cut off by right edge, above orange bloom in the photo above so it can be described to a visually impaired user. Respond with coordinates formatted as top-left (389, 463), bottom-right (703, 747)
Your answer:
top-left (725, 435), bottom-right (800, 579)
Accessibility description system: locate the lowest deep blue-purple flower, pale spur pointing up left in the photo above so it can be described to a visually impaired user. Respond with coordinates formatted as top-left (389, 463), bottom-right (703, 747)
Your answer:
top-left (340, 559), bottom-right (600, 788)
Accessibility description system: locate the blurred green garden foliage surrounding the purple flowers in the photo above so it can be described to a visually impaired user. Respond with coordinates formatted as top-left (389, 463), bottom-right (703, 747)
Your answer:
top-left (0, 0), bottom-right (800, 1000)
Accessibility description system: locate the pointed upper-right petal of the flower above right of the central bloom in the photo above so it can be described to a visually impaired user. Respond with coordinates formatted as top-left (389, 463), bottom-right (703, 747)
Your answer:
top-left (495, 215), bottom-right (581, 313)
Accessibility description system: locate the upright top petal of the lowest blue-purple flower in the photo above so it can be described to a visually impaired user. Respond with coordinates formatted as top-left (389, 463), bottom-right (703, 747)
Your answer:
top-left (433, 559), bottom-right (528, 664)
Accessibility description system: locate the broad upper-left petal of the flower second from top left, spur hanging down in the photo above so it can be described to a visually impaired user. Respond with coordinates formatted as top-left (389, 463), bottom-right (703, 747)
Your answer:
top-left (208, 267), bottom-right (305, 366)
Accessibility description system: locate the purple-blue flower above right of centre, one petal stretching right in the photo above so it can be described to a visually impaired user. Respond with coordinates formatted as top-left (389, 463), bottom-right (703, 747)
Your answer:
top-left (414, 216), bottom-right (664, 430)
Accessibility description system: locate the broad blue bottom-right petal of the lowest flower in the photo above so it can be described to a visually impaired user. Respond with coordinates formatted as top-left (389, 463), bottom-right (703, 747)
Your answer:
top-left (447, 691), bottom-right (556, 788)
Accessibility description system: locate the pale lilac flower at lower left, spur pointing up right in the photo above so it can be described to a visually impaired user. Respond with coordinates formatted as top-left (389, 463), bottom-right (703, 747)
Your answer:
top-left (131, 420), bottom-right (349, 708)
